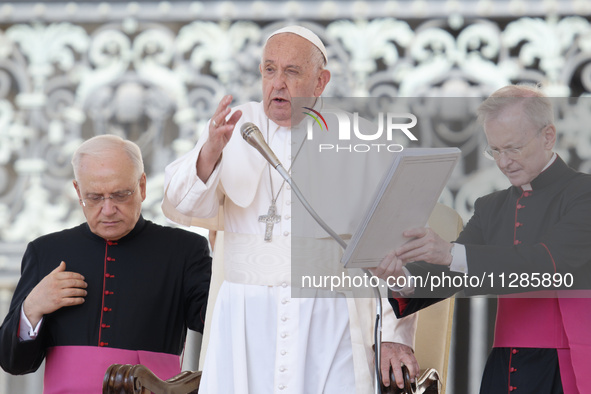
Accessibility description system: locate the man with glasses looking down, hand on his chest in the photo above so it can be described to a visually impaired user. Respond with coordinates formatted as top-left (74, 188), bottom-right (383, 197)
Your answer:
top-left (0, 135), bottom-right (211, 393)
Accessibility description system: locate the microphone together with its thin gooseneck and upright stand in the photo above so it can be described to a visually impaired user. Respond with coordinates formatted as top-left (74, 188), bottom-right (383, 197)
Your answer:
top-left (240, 122), bottom-right (382, 394)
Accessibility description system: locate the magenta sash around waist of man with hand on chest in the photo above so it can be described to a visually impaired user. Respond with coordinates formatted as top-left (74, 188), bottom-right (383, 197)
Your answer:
top-left (43, 346), bottom-right (181, 394)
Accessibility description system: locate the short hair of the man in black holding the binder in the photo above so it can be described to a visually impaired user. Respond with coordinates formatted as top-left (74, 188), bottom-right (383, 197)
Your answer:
top-left (477, 85), bottom-right (554, 128)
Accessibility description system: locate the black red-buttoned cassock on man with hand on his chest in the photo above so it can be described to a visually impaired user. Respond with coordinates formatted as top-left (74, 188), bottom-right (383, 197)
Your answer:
top-left (0, 217), bottom-right (211, 390)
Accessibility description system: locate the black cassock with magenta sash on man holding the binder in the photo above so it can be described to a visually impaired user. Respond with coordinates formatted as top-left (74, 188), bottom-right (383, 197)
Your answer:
top-left (390, 157), bottom-right (591, 394)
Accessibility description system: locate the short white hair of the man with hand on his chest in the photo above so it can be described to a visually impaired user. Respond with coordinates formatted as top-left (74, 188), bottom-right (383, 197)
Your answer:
top-left (72, 134), bottom-right (144, 179)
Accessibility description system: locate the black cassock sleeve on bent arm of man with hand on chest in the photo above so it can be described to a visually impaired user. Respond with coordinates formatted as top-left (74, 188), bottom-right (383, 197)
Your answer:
top-left (0, 243), bottom-right (46, 375)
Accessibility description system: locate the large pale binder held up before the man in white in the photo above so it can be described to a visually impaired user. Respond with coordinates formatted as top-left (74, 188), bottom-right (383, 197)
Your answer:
top-left (341, 148), bottom-right (461, 268)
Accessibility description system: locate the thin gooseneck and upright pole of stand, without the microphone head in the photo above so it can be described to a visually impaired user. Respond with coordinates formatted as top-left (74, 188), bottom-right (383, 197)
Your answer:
top-left (275, 163), bottom-right (382, 394)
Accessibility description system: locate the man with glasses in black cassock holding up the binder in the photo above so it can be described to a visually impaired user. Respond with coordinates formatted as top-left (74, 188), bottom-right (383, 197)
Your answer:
top-left (379, 86), bottom-right (591, 394)
